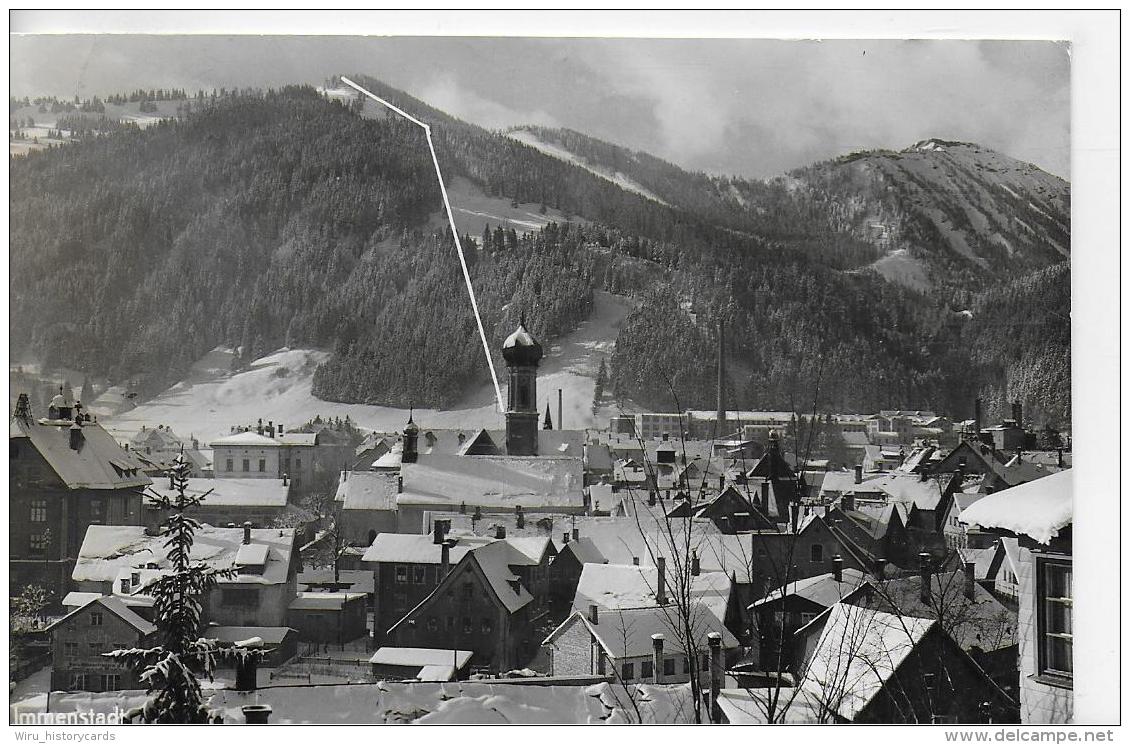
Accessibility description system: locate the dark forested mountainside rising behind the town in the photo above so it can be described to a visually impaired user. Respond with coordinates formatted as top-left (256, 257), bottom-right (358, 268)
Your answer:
top-left (9, 79), bottom-right (1070, 422)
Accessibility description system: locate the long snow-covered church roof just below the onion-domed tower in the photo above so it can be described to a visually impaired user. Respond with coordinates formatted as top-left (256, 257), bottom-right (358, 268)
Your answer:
top-left (397, 453), bottom-right (584, 510)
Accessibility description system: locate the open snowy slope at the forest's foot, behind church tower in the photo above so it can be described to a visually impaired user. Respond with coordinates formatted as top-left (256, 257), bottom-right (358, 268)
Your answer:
top-left (99, 293), bottom-right (631, 444)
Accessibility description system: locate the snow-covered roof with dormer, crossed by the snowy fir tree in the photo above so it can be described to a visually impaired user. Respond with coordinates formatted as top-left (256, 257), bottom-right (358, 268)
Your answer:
top-left (71, 523), bottom-right (295, 584)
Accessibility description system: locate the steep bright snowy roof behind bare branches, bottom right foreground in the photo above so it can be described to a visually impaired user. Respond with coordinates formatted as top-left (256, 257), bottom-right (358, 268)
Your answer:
top-left (800, 603), bottom-right (936, 721)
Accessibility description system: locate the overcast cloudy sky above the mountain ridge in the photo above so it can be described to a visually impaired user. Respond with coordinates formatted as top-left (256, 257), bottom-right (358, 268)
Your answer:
top-left (10, 35), bottom-right (1070, 177)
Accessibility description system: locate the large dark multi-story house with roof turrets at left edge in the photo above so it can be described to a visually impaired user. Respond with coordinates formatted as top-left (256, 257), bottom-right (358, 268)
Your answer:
top-left (8, 393), bottom-right (153, 599)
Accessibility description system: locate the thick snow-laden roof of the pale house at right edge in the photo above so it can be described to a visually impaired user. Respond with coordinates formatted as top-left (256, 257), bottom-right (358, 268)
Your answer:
top-left (958, 469), bottom-right (1075, 544)
